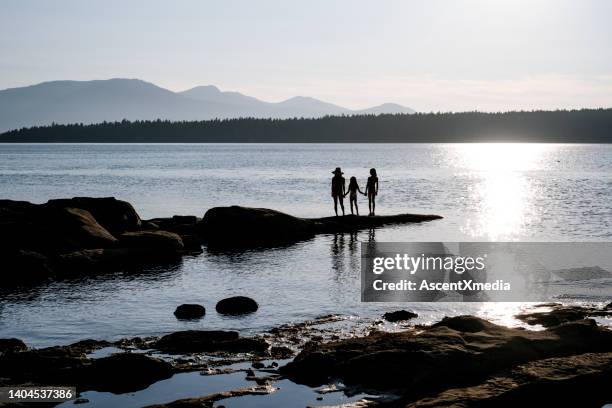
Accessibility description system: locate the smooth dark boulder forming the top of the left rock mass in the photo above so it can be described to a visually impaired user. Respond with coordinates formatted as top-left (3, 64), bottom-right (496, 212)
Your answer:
top-left (46, 197), bottom-right (141, 235)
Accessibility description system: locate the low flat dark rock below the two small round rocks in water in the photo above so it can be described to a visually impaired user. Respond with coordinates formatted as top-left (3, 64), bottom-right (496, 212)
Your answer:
top-left (153, 330), bottom-right (268, 353)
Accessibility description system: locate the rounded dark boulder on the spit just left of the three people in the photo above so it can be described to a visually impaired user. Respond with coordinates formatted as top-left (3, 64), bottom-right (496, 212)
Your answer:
top-left (198, 206), bottom-right (314, 247)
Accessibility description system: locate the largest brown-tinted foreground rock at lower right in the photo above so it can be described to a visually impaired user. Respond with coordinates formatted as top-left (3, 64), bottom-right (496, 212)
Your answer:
top-left (282, 316), bottom-right (612, 399)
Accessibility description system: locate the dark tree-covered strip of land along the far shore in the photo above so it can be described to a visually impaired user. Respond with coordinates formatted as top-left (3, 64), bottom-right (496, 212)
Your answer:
top-left (0, 109), bottom-right (612, 143)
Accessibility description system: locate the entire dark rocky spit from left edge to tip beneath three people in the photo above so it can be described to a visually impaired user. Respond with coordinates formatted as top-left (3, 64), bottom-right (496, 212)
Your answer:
top-left (0, 197), bottom-right (441, 287)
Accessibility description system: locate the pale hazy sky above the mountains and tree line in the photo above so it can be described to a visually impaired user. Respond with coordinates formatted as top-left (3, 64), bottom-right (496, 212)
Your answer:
top-left (0, 0), bottom-right (612, 111)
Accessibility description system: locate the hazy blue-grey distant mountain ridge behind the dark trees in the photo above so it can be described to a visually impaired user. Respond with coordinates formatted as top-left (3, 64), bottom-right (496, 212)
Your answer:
top-left (0, 78), bottom-right (415, 132)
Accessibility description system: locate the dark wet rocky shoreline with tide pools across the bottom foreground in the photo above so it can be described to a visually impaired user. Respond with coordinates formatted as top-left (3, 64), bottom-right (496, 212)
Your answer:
top-left (0, 304), bottom-right (612, 407)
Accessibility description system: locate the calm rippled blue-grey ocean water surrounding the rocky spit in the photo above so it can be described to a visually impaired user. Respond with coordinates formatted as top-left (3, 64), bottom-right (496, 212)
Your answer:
top-left (0, 144), bottom-right (612, 346)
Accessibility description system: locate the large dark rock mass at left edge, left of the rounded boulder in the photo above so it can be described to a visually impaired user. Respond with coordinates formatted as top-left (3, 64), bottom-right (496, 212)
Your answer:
top-left (0, 197), bottom-right (201, 286)
